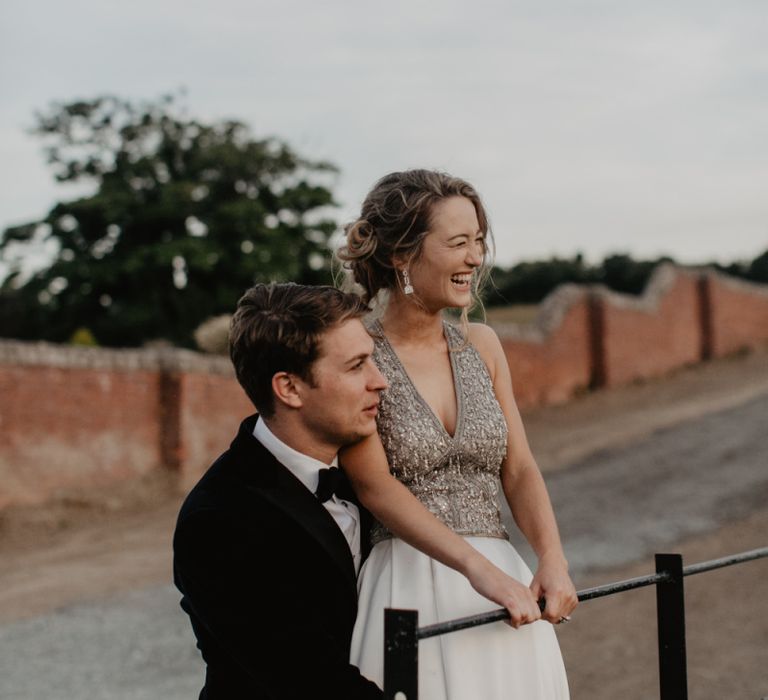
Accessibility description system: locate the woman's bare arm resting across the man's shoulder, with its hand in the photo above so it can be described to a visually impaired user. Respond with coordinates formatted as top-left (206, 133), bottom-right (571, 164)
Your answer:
top-left (340, 433), bottom-right (541, 627)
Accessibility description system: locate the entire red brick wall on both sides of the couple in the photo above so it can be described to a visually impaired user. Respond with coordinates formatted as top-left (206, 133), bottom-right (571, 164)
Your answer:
top-left (0, 265), bottom-right (768, 509)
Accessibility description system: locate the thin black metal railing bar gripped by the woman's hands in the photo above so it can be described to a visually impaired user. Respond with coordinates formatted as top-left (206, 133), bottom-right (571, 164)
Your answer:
top-left (416, 547), bottom-right (768, 639)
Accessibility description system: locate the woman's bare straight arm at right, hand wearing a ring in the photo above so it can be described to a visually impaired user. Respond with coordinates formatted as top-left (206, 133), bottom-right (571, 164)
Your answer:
top-left (470, 324), bottom-right (578, 622)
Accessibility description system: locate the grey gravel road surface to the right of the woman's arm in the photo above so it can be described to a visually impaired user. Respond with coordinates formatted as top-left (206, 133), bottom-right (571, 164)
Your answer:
top-left (516, 395), bottom-right (768, 576)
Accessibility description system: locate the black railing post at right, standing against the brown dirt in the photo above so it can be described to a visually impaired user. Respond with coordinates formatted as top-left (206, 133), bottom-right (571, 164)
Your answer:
top-left (656, 554), bottom-right (688, 700)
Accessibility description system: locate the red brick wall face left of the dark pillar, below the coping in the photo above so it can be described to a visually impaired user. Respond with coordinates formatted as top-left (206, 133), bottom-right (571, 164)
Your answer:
top-left (0, 366), bottom-right (162, 507)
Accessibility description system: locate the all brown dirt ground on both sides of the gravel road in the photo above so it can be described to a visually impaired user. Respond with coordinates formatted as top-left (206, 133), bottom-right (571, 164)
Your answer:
top-left (0, 352), bottom-right (768, 700)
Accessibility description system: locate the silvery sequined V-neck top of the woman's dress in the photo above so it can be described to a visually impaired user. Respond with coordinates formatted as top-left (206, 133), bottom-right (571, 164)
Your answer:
top-left (369, 321), bottom-right (508, 544)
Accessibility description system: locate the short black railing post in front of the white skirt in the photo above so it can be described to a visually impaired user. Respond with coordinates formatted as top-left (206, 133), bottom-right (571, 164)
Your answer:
top-left (384, 608), bottom-right (419, 700)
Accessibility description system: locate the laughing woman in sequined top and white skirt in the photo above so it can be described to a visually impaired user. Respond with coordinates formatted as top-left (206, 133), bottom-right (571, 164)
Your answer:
top-left (339, 170), bottom-right (577, 700)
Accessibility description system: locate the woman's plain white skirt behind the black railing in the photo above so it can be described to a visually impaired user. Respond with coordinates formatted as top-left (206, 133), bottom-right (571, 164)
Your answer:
top-left (351, 537), bottom-right (569, 700)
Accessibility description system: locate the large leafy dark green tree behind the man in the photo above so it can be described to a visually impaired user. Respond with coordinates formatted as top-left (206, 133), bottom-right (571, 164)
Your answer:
top-left (0, 96), bottom-right (336, 346)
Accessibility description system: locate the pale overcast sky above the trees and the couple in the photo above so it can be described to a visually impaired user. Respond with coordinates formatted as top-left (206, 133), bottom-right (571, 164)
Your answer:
top-left (0, 0), bottom-right (768, 265)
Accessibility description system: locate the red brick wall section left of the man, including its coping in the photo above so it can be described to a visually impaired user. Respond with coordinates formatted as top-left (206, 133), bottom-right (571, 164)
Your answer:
top-left (0, 341), bottom-right (253, 508)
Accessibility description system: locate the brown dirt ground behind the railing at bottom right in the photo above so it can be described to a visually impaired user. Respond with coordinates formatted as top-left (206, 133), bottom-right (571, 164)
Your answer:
top-left (557, 507), bottom-right (768, 700)
